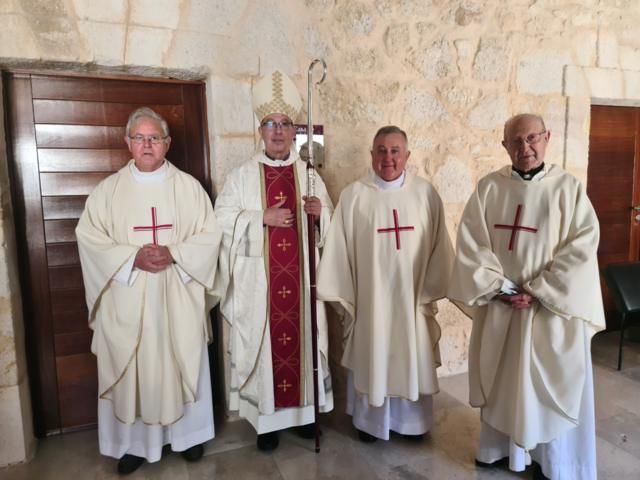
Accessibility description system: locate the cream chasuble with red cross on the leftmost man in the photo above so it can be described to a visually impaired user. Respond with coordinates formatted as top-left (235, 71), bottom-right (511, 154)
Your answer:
top-left (76, 161), bottom-right (221, 425)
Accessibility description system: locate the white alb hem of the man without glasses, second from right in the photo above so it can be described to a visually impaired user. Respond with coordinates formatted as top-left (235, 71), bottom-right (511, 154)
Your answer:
top-left (346, 370), bottom-right (433, 440)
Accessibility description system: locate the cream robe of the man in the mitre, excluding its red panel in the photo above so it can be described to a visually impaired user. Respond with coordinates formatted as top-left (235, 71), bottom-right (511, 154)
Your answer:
top-left (215, 149), bottom-right (333, 433)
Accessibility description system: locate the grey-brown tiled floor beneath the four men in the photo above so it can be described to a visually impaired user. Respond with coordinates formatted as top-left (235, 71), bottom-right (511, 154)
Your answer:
top-left (0, 332), bottom-right (640, 480)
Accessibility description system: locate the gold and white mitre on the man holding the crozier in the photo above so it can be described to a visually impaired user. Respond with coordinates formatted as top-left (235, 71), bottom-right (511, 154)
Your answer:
top-left (252, 70), bottom-right (302, 121)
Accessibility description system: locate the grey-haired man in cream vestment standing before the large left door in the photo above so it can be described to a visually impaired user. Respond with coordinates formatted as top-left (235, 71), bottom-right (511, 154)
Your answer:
top-left (76, 107), bottom-right (222, 474)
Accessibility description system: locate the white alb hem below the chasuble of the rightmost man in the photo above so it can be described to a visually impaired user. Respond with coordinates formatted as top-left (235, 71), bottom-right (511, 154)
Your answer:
top-left (476, 339), bottom-right (598, 480)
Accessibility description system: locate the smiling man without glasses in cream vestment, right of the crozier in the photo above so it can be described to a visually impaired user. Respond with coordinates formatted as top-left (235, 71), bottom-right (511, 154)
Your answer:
top-left (318, 126), bottom-right (453, 442)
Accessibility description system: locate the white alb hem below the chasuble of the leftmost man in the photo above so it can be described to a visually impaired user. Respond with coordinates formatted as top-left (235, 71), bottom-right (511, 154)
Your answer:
top-left (98, 344), bottom-right (215, 463)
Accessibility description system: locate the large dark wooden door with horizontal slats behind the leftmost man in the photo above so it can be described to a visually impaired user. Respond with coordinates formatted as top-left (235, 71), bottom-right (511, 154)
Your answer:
top-left (3, 72), bottom-right (210, 435)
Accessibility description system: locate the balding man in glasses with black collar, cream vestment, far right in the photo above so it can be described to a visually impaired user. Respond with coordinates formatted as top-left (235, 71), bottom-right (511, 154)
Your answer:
top-left (449, 114), bottom-right (604, 480)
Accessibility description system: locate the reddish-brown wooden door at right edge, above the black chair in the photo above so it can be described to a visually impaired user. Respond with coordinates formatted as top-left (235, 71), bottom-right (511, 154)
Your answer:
top-left (587, 105), bottom-right (640, 329)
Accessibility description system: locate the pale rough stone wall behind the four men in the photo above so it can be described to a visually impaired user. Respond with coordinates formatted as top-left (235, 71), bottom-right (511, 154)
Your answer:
top-left (0, 0), bottom-right (640, 464)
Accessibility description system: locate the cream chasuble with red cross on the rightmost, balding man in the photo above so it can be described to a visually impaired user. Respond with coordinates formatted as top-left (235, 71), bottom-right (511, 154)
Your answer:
top-left (449, 166), bottom-right (604, 449)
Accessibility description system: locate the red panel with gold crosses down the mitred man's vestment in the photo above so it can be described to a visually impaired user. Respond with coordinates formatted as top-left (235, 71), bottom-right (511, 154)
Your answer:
top-left (262, 164), bottom-right (304, 408)
